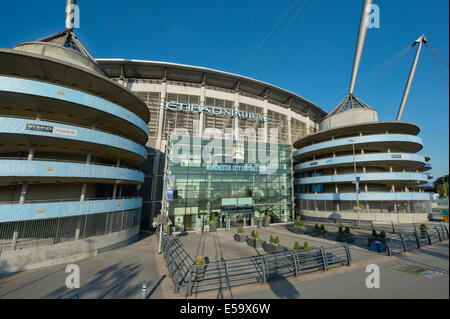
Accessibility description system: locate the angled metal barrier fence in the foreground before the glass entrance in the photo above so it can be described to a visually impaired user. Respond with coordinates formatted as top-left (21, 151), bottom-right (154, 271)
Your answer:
top-left (161, 234), bottom-right (351, 296)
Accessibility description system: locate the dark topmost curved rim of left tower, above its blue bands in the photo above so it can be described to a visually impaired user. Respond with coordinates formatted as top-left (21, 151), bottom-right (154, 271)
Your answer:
top-left (0, 49), bottom-right (150, 122)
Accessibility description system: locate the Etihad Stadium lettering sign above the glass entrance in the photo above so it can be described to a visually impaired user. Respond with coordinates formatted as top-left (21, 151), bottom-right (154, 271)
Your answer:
top-left (165, 102), bottom-right (267, 122)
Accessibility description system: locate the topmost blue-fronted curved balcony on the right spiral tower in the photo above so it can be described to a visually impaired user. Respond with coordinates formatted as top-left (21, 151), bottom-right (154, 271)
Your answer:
top-left (294, 134), bottom-right (422, 160)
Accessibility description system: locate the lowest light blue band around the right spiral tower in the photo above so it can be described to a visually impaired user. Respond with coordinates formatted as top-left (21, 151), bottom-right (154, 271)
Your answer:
top-left (296, 192), bottom-right (431, 201)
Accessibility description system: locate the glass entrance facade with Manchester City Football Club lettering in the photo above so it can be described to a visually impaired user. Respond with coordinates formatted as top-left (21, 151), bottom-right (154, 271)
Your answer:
top-left (167, 136), bottom-right (293, 231)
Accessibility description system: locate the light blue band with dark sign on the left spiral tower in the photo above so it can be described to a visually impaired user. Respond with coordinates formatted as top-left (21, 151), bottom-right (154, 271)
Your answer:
top-left (0, 117), bottom-right (147, 159)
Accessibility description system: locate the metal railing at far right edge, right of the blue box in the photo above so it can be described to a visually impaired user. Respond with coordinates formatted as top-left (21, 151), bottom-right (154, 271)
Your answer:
top-left (386, 224), bottom-right (448, 256)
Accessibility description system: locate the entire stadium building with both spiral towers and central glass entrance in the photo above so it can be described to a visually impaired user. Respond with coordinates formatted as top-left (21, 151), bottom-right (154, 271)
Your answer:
top-left (0, 1), bottom-right (431, 270)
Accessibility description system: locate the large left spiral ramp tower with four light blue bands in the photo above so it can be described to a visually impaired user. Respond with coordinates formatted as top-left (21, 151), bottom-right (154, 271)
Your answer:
top-left (0, 30), bottom-right (149, 270)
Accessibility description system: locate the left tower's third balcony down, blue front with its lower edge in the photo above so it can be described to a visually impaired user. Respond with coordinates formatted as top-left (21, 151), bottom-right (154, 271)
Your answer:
top-left (0, 158), bottom-right (144, 185)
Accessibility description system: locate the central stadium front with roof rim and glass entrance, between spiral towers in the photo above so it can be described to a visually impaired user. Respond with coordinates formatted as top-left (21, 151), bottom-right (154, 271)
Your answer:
top-left (97, 59), bottom-right (327, 231)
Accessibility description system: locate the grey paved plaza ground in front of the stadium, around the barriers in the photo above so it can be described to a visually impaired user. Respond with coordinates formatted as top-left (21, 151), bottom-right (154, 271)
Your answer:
top-left (0, 224), bottom-right (449, 299)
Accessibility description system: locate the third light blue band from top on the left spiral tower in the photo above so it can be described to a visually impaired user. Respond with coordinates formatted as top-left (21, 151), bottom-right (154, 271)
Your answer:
top-left (0, 159), bottom-right (144, 183)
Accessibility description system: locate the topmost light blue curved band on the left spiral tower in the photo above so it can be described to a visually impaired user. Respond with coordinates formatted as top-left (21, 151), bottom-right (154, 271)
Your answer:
top-left (0, 76), bottom-right (148, 135)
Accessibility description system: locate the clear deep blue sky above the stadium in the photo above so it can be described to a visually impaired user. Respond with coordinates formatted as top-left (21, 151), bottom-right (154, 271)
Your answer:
top-left (0, 0), bottom-right (449, 177)
